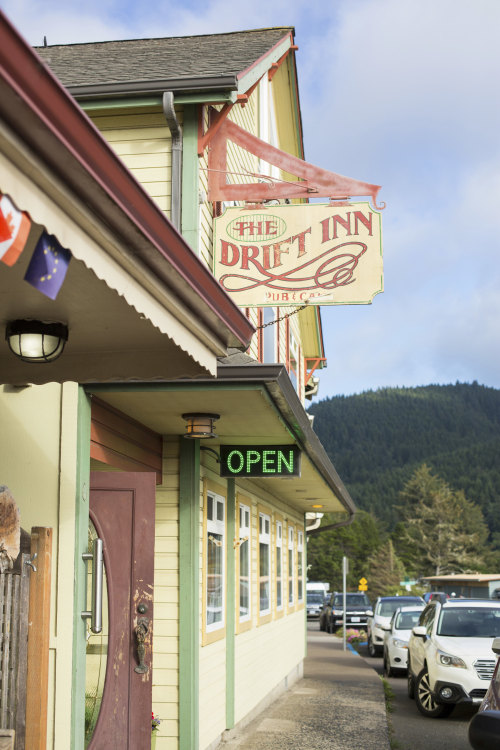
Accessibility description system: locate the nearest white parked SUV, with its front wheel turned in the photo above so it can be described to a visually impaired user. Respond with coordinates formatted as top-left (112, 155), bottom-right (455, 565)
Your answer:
top-left (408, 599), bottom-right (500, 718)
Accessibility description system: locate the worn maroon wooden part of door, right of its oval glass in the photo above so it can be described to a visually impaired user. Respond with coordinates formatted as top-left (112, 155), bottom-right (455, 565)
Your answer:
top-left (88, 472), bottom-right (156, 750)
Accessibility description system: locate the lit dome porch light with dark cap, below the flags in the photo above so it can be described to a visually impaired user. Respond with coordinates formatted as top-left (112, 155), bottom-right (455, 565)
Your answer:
top-left (5, 320), bottom-right (68, 363)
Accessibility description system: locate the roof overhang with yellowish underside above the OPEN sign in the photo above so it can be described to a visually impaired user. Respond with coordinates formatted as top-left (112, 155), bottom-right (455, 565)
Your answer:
top-left (87, 362), bottom-right (356, 518)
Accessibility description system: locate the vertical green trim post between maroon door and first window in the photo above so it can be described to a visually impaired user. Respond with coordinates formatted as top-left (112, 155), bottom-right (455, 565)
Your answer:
top-left (179, 437), bottom-right (200, 750)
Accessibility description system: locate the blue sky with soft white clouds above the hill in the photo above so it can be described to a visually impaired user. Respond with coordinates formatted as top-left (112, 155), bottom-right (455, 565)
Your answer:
top-left (0, 0), bottom-right (500, 399)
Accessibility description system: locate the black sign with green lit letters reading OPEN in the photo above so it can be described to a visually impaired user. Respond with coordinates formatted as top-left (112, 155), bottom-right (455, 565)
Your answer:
top-left (220, 445), bottom-right (300, 477)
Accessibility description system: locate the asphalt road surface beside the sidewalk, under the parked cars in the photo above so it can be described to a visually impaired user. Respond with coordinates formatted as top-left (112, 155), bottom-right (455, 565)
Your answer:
top-left (361, 648), bottom-right (477, 750)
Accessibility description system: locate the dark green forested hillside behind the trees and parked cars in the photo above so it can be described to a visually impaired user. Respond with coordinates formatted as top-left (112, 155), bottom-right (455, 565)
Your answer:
top-left (308, 383), bottom-right (500, 547)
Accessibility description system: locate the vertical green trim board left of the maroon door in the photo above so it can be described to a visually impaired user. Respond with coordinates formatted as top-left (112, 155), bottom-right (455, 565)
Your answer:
top-left (71, 386), bottom-right (90, 750)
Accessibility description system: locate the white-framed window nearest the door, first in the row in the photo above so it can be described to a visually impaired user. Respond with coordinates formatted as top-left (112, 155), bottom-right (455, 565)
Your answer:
top-left (205, 492), bottom-right (226, 632)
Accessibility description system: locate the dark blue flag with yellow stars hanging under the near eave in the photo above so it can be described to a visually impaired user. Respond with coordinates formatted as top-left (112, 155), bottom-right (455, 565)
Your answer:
top-left (24, 232), bottom-right (71, 299)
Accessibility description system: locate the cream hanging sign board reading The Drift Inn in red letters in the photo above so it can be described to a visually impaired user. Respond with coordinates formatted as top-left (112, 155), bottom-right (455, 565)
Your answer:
top-left (214, 202), bottom-right (383, 307)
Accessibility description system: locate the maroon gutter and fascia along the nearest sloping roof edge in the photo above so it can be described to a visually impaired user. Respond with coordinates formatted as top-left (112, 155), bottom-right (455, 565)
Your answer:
top-left (0, 11), bottom-right (254, 348)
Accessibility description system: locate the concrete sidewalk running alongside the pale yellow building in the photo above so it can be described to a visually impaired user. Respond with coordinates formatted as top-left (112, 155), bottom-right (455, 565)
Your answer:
top-left (219, 631), bottom-right (390, 750)
